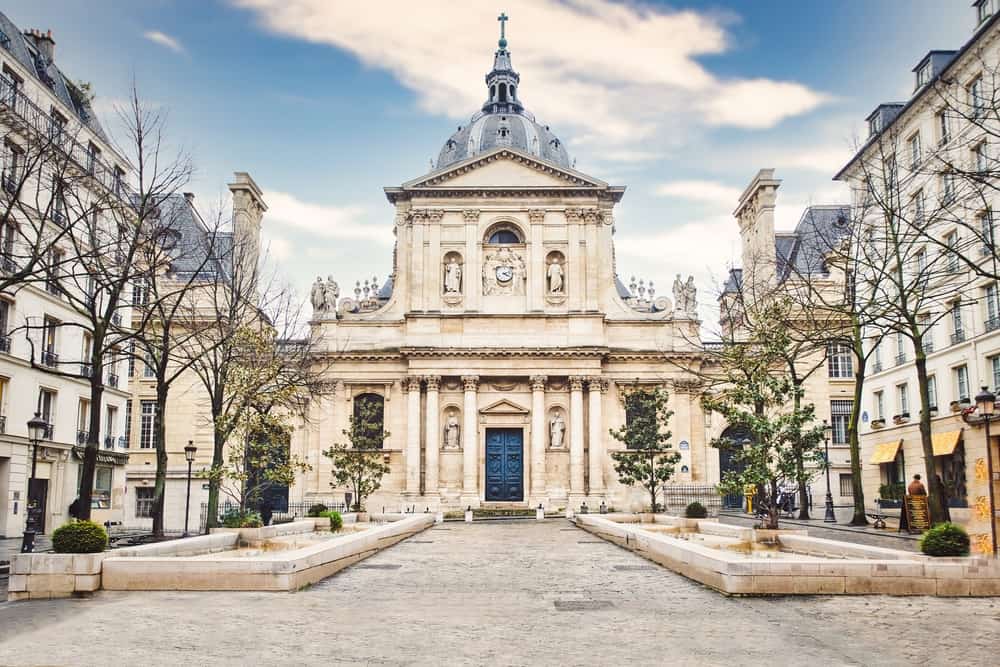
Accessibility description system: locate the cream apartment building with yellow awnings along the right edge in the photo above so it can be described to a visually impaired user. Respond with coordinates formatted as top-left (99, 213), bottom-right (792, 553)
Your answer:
top-left (835, 0), bottom-right (1000, 552)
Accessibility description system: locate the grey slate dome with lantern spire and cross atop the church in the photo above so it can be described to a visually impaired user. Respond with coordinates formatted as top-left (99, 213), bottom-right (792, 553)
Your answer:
top-left (436, 15), bottom-right (573, 169)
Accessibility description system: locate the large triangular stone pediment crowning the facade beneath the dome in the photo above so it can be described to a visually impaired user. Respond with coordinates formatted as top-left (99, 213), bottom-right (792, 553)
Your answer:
top-left (403, 148), bottom-right (608, 190)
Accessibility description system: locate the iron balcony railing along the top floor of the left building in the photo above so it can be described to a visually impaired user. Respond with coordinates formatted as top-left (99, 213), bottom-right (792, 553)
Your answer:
top-left (0, 75), bottom-right (132, 201)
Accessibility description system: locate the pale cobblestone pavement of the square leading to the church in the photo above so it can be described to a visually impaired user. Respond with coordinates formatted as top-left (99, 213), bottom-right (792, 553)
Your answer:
top-left (0, 520), bottom-right (1000, 667)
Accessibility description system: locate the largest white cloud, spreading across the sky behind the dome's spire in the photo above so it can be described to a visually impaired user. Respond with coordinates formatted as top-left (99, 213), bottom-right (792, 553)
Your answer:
top-left (231, 0), bottom-right (826, 160)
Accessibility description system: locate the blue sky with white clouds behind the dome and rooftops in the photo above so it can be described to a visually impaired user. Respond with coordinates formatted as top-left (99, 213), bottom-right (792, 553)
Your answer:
top-left (3, 0), bottom-right (974, 318)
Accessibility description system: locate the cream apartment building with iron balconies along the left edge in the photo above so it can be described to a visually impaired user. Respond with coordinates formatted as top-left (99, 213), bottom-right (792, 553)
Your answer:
top-left (0, 14), bottom-right (129, 537)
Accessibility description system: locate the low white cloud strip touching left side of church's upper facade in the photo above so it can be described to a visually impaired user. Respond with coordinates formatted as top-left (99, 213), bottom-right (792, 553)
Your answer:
top-left (264, 190), bottom-right (393, 246)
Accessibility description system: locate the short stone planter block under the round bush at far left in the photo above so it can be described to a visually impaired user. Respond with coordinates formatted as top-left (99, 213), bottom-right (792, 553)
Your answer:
top-left (7, 551), bottom-right (110, 600)
